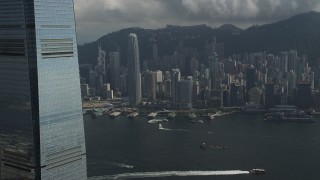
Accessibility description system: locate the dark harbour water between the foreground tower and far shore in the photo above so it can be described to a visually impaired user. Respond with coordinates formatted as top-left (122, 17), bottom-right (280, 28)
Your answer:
top-left (85, 114), bottom-right (320, 180)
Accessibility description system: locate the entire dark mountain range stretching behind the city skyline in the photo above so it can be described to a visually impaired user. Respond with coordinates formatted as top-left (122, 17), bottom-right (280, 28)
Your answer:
top-left (78, 12), bottom-right (320, 65)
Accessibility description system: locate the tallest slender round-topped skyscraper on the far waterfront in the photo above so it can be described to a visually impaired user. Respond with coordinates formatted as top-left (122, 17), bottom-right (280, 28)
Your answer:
top-left (128, 33), bottom-right (141, 106)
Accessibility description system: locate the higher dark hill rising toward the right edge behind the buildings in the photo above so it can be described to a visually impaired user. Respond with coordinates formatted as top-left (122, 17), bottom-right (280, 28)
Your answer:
top-left (226, 12), bottom-right (320, 59)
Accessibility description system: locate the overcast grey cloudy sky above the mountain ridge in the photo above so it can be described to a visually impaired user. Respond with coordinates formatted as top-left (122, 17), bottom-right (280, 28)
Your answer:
top-left (74, 0), bottom-right (320, 44)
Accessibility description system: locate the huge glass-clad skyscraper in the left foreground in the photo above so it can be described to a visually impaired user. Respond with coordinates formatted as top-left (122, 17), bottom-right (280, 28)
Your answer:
top-left (0, 0), bottom-right (87, 180)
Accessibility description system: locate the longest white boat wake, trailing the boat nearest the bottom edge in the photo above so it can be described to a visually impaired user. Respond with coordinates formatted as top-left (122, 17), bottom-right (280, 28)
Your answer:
top-left (89, 170), bottom-right (250, 180)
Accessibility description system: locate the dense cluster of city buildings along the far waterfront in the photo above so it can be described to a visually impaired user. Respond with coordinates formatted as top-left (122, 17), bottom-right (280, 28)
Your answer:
top-left (82, 34), bottom-right (320, 109)
